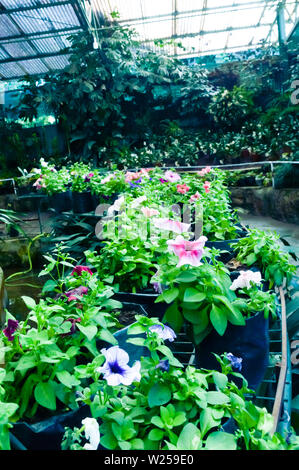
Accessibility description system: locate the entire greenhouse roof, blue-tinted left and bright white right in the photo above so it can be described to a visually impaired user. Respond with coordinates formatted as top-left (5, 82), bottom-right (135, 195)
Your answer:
top-left (0, 0), bottom-right (298, 81)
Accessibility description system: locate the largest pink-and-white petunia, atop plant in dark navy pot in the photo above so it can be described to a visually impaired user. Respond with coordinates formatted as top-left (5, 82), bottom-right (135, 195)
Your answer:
top-left (167, 235), bottom-right (207, 268)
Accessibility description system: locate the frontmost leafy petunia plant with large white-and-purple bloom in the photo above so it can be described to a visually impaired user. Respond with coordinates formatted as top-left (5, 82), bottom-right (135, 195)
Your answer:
top-left (61, 317), bottom-right (298, 451)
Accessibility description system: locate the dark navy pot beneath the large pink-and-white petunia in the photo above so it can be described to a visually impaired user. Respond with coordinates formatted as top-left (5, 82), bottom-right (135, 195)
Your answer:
top-left (195, 311), bottom-right (269, 390)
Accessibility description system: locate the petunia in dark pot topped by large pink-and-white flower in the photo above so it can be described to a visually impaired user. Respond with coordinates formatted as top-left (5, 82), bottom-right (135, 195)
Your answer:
top-left (157, 237), bottom-right (273, 389)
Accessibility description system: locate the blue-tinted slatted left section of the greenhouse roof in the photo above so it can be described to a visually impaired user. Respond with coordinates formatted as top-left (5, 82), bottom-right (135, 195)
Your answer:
top-left (0, 0), bottom-right (88, 80)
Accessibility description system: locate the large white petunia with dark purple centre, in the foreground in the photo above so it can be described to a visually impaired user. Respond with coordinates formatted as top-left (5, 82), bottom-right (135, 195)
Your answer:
top-left (96, 346), bottom-right (141, 385)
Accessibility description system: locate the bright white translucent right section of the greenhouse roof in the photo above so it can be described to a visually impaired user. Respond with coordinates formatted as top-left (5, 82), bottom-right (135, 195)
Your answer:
top-left (90, 0), bottom-right (299, 58)
